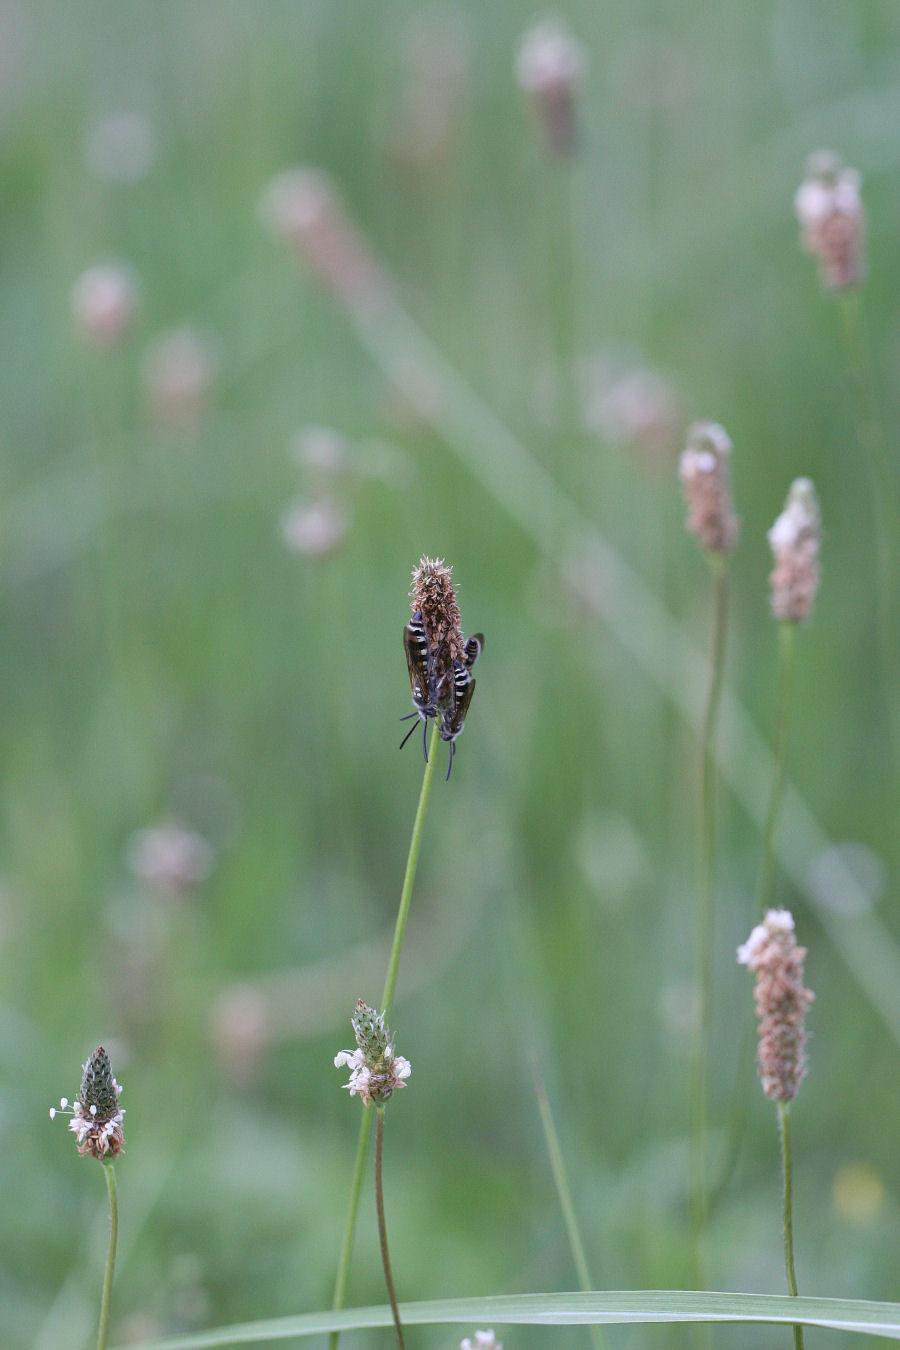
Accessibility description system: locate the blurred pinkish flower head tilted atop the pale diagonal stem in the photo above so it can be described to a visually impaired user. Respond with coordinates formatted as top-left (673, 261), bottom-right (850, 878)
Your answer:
top-left (259, 169), bottom-right (387, 311)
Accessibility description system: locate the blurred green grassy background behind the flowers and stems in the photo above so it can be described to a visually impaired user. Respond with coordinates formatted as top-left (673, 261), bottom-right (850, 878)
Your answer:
top-left (0, 0), bottom-right (900, 1350)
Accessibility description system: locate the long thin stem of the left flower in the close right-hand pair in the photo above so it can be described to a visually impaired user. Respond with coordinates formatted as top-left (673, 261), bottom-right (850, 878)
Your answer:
top-left (690, 554), bottom-right (729, 1284)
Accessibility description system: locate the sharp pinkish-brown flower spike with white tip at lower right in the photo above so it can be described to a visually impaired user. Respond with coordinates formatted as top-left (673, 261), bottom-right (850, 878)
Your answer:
top-left (738, 910), bottom-right (814, 1102)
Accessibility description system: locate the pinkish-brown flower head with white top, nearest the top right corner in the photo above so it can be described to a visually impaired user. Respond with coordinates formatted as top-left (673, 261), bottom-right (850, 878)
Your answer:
top-left (793, 150), bottom-right (865, 290)
